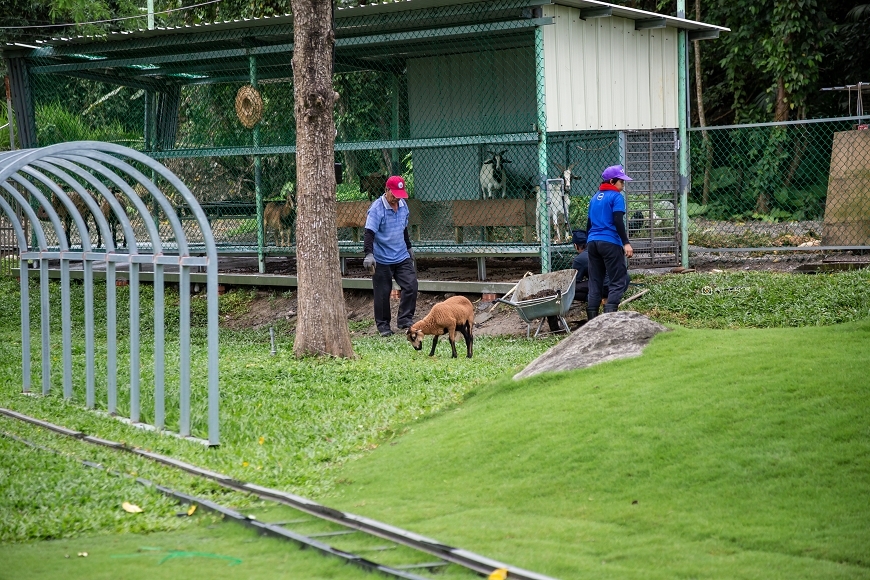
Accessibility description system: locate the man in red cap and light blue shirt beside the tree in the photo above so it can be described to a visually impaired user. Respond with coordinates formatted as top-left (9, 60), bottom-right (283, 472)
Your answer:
top-left (363, 175), bottom-right (417, 336)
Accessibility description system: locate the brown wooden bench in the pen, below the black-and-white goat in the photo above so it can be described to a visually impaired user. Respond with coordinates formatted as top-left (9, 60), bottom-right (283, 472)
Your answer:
top-left (453, 199), bottom-right (537, 244)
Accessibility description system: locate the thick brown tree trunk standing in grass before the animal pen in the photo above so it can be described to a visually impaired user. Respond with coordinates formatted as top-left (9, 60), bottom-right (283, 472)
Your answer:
top-left (292, 0), bottom-right (354, 357)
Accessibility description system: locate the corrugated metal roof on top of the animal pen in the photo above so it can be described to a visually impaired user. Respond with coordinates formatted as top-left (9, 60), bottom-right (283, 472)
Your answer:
top-left (7, 0), bottom-right (729, 48)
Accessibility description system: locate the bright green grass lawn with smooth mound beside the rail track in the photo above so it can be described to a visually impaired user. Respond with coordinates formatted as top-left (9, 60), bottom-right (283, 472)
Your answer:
top-left (0, 271), bottom-right (870, 578)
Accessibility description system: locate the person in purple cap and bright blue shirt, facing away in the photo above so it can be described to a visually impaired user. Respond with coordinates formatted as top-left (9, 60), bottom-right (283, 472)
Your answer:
top-left (586, 165), bottom-right (634, 320)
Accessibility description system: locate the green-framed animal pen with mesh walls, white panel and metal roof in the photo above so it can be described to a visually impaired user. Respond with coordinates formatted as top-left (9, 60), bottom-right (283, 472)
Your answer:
top-left (3, 0), bottom-right (727, 279)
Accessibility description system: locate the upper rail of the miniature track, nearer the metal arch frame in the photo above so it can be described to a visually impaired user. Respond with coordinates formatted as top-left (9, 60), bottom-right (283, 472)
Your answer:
top-left (0, 407), bottom-right (555, 580)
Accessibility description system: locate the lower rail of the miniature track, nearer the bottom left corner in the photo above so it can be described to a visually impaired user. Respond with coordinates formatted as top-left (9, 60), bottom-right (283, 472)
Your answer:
top-left (0, 432), bottom-right (428, 580)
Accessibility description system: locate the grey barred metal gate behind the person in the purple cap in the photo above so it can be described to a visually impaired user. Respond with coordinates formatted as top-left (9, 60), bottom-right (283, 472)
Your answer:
top-left (623, 130), bottom-right (680, 267)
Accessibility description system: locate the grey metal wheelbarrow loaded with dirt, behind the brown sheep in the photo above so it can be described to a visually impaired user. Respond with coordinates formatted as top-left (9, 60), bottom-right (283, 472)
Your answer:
top-left (499, 268), bottom-right (577, 338)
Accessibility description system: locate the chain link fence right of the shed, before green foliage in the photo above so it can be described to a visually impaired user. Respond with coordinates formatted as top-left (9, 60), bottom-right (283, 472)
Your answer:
top-left (687, 118), bottom-right (870, 250)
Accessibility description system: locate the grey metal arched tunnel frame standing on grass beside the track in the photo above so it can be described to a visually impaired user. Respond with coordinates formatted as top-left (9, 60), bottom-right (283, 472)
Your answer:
top-left (0, 141), bottom-right (219, 445)
